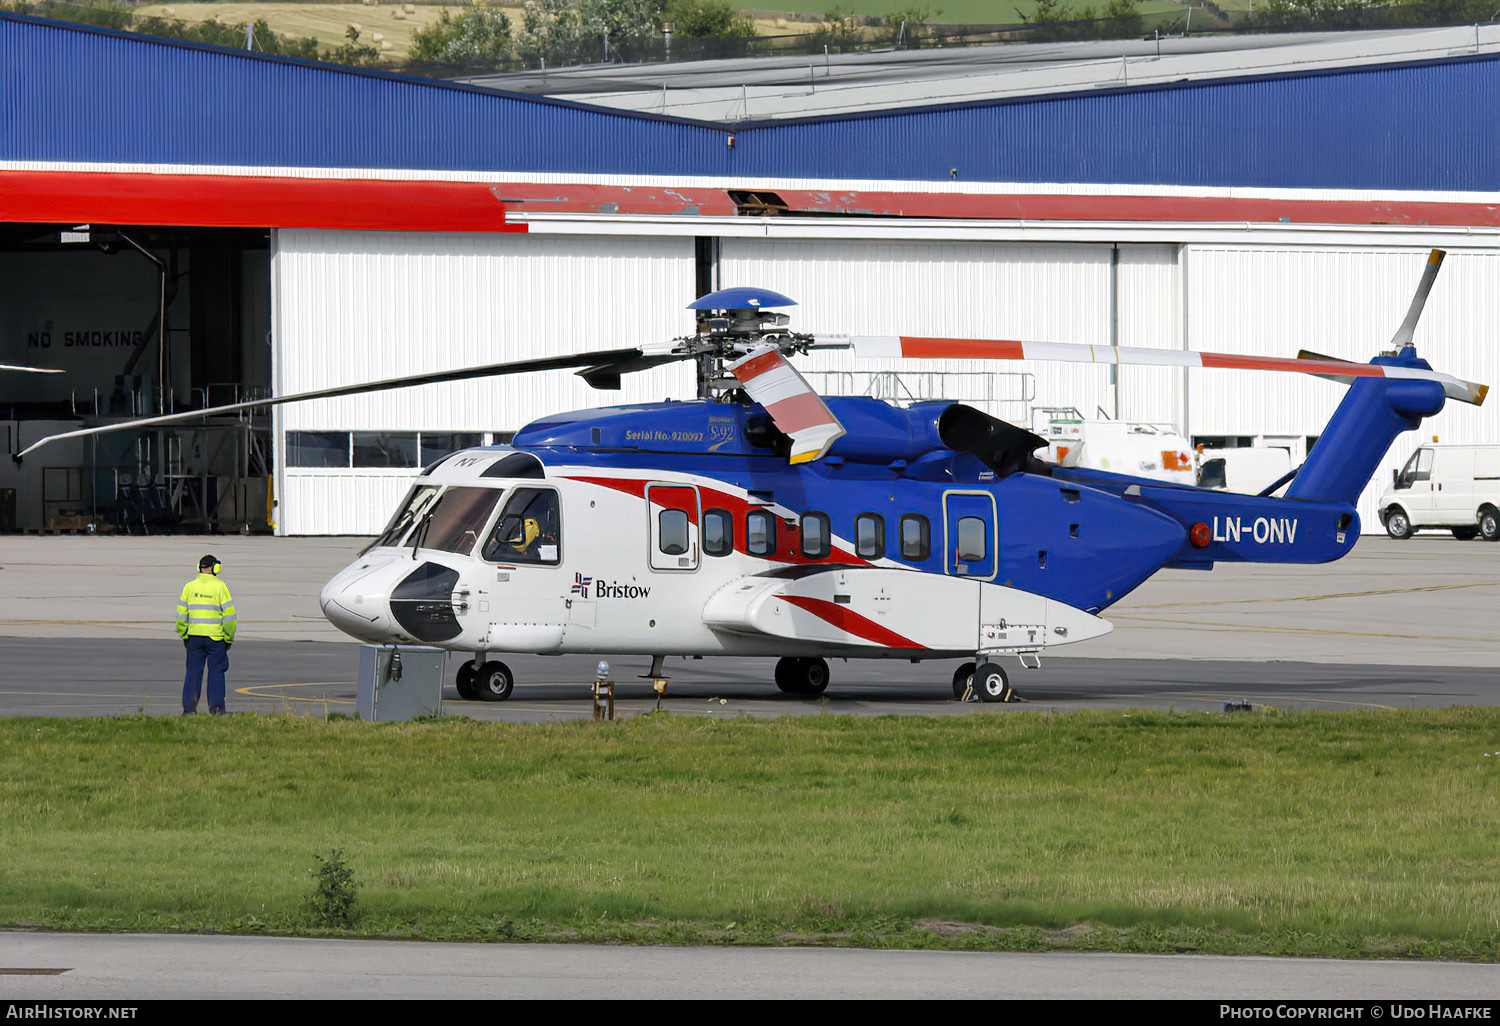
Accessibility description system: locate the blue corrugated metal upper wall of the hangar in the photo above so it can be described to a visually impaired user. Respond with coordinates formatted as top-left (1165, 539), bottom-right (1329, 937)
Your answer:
top-left (0, 17), bottom-right (1500, 191)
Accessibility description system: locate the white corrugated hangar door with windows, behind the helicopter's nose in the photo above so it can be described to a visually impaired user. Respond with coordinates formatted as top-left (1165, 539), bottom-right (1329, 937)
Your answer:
top-left (272, 230), bottom-right (695, 534)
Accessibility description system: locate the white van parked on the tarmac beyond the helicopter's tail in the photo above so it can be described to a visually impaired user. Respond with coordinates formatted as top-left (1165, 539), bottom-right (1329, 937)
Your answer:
top-left (1380, 446), bottom-right (1500, 542)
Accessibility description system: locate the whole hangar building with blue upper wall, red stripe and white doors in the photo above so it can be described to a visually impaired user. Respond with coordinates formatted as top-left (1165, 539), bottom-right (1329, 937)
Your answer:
top-left (0, 15), bottom-right (1500, 534)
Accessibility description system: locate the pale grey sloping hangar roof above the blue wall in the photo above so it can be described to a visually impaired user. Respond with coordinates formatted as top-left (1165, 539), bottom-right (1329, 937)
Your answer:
top-left (459, 24), bottom-right (1500, 125)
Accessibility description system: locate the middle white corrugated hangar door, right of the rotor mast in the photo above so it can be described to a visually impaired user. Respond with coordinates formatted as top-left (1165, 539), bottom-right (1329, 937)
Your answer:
top-left (720, 239), bottom-right (1182, 438)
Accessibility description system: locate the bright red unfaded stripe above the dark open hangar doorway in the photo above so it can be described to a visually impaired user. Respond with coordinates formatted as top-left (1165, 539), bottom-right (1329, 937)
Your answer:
top-left (0, 171), bottom-right (527, 233)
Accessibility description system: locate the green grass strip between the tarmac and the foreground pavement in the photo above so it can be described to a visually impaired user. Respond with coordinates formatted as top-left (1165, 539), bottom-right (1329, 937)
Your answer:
top-left (0, 708), bottom-right (1500, 960)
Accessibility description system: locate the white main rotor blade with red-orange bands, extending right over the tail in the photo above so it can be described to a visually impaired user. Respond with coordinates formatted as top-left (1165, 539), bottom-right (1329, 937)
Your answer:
top-left (818, 335), bottom-right (1490, 407)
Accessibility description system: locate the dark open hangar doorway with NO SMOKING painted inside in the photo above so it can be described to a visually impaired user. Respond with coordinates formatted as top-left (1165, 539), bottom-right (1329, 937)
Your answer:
top-left (0, 224), bottom-right (270, 533)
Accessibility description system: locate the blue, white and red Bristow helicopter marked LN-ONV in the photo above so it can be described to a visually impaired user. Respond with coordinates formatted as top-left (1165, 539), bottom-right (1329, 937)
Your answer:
top-left (18, 251), bottom-right (1488, 702)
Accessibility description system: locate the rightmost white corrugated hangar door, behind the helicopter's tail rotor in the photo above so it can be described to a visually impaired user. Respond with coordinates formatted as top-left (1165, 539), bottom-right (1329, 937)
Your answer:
top-left (1184, 245), bottom-right (1500, 534)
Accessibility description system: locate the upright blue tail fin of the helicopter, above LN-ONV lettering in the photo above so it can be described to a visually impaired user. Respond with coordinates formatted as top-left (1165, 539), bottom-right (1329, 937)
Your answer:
top-left (1286, 347), bottom-right (1445, 506)
